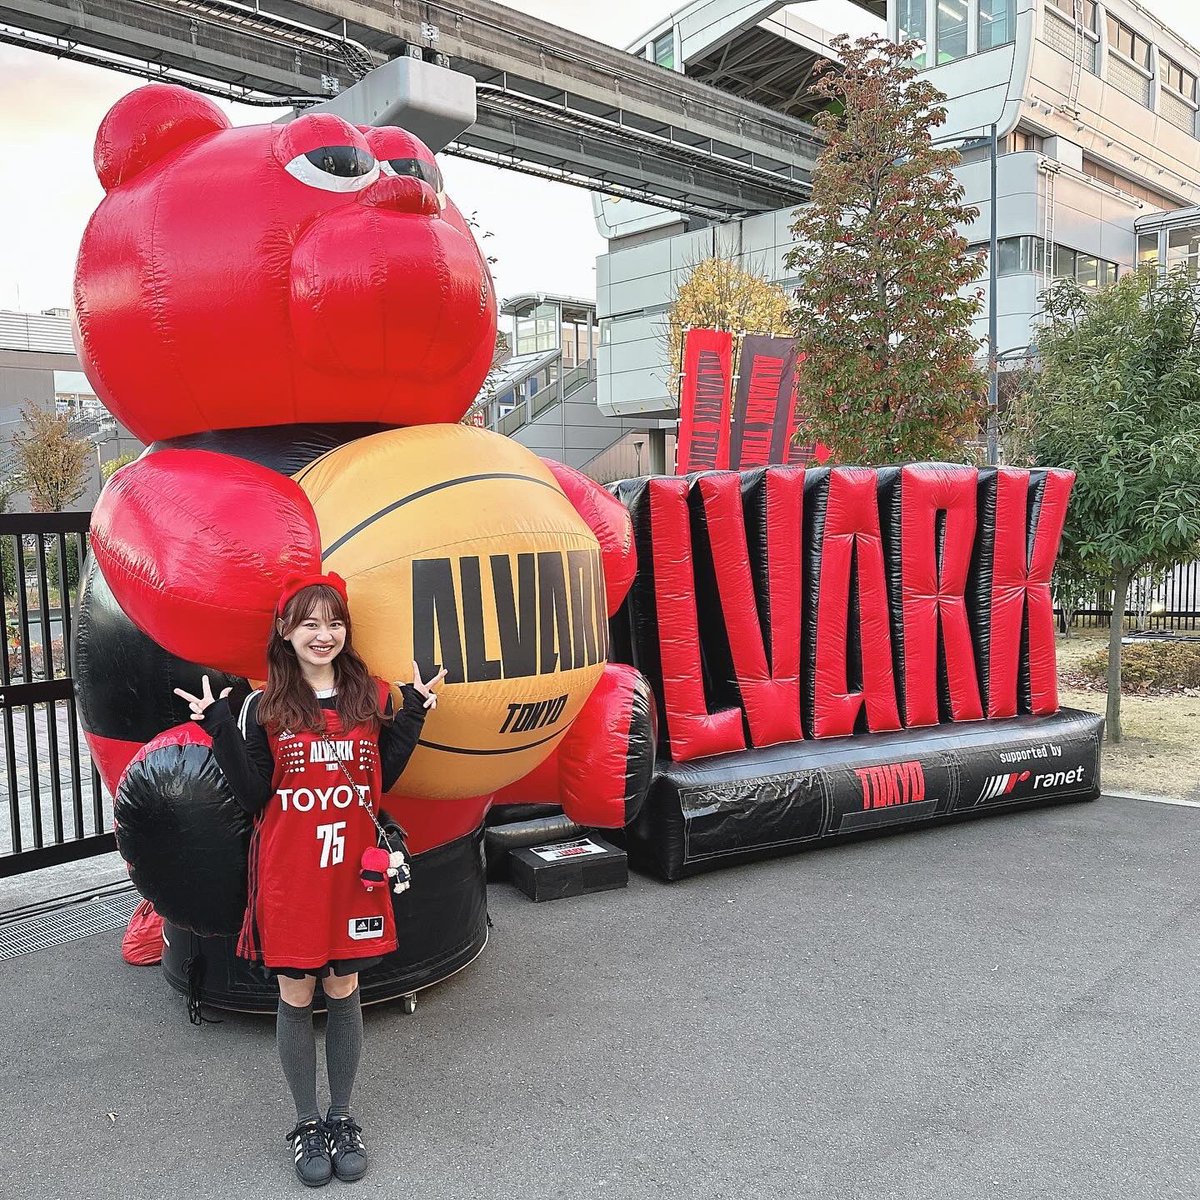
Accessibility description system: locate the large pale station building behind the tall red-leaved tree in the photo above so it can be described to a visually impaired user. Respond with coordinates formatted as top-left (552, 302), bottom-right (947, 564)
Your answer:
top-left (596, 0), bottom-right (1200, 439)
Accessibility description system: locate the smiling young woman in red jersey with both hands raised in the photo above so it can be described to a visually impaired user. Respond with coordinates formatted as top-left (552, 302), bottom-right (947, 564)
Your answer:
top-left (175, 574), bottom-right (445, 1187)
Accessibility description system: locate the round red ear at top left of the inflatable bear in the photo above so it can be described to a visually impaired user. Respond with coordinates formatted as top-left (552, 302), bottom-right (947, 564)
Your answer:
top-left (94, 83), bottom-right (229, 192)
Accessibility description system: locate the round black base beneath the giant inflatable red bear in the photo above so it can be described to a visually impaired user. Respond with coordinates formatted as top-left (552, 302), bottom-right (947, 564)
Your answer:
top-left (162, 829), bottom-right (487, 1013)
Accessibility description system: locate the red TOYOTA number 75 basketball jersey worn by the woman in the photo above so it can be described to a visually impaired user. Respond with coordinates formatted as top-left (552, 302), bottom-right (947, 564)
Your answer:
top-left (238, 682), bottom-right (396, 968)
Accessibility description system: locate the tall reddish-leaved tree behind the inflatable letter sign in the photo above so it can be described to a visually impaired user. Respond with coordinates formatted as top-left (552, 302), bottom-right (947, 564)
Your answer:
top-left (787, 37), bottom-right (986, 463)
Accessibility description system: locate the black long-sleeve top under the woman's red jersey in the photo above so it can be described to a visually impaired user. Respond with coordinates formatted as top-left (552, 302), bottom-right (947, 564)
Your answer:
top-left (202, 684), bottom-right (426, 816)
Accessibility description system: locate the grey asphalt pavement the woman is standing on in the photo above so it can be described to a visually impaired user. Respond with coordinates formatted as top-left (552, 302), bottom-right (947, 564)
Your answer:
top-left (0, 798), bottom-right (1200, 1200)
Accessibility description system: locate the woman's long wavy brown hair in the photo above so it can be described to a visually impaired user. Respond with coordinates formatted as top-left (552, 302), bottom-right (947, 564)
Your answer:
top-left (258, 583), bottom-right (383, 733)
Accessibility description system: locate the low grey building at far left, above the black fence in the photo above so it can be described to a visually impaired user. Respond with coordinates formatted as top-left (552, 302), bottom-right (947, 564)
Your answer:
top-left (0, 308), bottom-right (142, 512)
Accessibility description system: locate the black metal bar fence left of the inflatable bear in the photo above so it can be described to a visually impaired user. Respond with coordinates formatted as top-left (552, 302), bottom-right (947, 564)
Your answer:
top-left (0, 512), bottom-right (115, 876)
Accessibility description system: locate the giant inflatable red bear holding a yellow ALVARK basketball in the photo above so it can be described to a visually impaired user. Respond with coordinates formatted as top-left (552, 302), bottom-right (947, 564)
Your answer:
top-left (73, 84), bottom-right (656, 1009)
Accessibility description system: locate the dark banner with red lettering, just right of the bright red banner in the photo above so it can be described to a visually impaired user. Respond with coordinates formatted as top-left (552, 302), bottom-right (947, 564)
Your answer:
top-left (730, 335), bottom-right (798, 470)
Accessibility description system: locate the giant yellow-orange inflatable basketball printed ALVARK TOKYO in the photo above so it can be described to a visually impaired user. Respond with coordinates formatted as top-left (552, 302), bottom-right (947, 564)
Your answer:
top-left (295, 425), bottom-right (608, 798)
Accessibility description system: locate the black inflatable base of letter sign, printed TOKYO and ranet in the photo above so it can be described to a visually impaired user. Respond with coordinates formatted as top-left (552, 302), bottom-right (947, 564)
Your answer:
top-left (625, 708), bottom-right (1104, 880)
